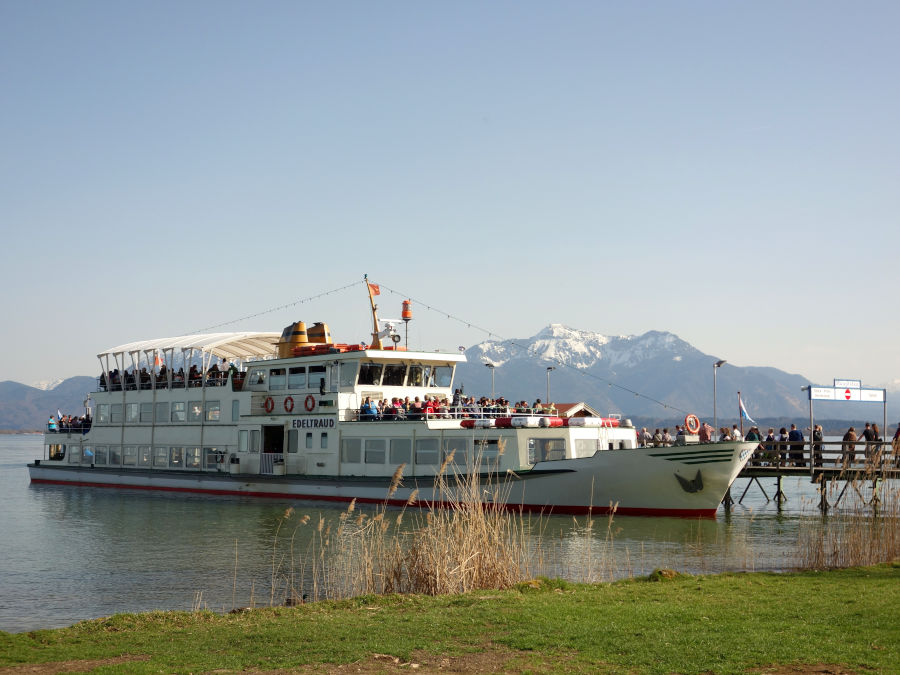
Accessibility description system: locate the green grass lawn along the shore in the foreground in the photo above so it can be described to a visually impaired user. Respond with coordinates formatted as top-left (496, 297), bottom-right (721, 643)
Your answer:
top-left (0, 563), bottom-right (900, 673)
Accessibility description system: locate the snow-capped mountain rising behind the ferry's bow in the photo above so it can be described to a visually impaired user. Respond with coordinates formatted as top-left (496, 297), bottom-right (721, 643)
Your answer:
top-left (456, 324), bottom-right (820, 420)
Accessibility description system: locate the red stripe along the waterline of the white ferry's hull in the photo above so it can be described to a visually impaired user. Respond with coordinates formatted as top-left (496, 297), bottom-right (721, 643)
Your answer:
top-left (31, 478), bottom-right (716, 519)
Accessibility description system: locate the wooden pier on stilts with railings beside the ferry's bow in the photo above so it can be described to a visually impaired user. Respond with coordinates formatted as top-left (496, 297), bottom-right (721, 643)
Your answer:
top-left (722, 440), bottom-right (900, 512)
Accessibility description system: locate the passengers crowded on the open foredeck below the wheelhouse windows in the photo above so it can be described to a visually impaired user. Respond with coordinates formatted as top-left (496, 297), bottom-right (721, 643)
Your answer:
top-left (359, 389), bottom-right (557, 421)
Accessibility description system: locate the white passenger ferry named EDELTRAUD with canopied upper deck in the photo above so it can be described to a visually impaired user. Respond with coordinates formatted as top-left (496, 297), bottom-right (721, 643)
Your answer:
top-left (28, 280), bottom-right (757, 517)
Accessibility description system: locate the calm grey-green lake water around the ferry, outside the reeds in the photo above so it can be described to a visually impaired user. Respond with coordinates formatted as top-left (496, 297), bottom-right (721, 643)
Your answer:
top-left (0, 435), bottom-right (876, 632)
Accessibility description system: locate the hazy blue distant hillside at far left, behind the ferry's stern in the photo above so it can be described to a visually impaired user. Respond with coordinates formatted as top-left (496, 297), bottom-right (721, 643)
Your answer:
top-left (0, 377), bottom-right (97, 431)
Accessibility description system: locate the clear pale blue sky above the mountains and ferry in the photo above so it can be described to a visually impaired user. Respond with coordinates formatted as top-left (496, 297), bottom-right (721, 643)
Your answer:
top-left (0, 0), bottom-right (900, 386)
